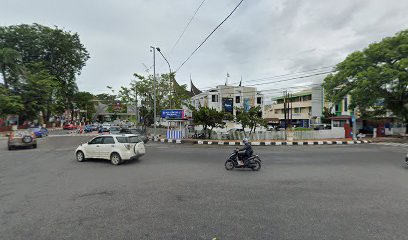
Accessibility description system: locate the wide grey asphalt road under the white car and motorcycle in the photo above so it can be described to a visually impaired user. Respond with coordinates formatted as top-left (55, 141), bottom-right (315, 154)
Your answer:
top-left (0, 136), bottom-right (408, 239)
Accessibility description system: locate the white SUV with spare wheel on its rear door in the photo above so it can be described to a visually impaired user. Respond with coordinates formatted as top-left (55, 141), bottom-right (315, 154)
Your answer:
top-left (75, 134), bottom-right (146, 165)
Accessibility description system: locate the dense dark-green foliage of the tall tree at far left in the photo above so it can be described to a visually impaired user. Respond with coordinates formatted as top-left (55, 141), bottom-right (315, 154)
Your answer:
top-left (0, 24), bottom-right (89, 121)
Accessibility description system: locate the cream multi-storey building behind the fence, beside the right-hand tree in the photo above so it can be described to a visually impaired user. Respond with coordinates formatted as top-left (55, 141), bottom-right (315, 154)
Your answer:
top-left (263, 86), bottom-right (324, 127)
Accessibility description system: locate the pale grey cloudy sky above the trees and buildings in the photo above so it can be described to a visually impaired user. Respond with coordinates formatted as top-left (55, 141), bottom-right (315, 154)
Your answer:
top-left (0, 0), bottom-right (408, 95)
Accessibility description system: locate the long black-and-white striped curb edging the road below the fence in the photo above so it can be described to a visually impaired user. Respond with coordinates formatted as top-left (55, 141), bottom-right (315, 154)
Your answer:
top-left (155, 139), bottom-right (371, 146)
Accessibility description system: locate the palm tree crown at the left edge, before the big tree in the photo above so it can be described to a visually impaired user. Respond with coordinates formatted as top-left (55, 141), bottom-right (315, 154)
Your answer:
top-left (0, 48), bottom-right (24, 89)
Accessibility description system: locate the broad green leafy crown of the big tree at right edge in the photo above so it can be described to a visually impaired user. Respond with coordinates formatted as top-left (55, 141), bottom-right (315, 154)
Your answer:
top-left (324, 30), bottom-right (408, 132)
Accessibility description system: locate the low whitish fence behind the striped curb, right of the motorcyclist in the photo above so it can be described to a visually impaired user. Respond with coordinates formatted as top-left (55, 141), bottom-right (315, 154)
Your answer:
top-left (220, 128), bottom-right (344, 140)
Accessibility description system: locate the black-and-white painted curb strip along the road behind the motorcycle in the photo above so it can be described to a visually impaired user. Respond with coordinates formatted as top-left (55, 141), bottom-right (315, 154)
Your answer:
top-left (156, 138), bottom-right (371, 146)
